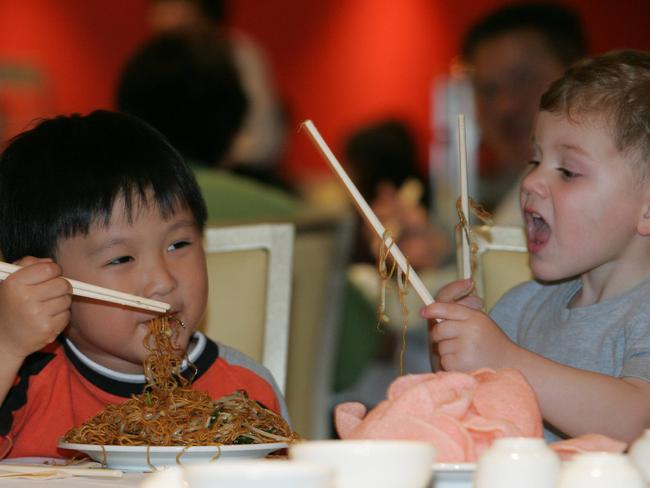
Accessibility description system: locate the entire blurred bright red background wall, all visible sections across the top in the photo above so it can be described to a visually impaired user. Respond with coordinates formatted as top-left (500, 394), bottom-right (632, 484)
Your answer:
top-left (0, 0), bottom-right (650, 180)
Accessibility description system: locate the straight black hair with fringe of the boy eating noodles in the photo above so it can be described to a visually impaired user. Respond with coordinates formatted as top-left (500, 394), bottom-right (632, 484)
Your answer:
top-left (0, 110), bottom-right (206, 261)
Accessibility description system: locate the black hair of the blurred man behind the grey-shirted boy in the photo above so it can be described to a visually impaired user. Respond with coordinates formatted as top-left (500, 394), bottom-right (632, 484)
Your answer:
top-left (461, 2), bottom-right (587, 66)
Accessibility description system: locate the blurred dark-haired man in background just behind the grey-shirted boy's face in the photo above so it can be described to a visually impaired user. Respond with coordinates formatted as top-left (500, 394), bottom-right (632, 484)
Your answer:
top-left (462, 2), bottom-right (587, 225)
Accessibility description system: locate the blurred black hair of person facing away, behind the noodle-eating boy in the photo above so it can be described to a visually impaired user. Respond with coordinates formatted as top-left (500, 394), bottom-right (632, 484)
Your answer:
top-left (117, 32), bottom-right (248, 166)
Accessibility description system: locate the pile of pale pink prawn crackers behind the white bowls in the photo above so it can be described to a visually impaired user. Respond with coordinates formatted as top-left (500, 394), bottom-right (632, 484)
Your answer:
top-left (335, 369), bottom-right (542, 462)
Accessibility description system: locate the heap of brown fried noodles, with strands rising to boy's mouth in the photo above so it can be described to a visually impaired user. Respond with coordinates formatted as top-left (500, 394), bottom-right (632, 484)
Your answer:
top-left (64, 316), bottom-right (297, 447)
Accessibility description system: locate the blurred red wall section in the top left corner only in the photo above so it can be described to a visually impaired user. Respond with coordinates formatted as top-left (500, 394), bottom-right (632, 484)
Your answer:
top-left (0, 0), bottom-right (146, 136)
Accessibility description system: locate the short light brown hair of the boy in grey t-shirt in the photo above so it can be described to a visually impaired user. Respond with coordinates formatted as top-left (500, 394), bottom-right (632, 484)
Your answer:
top-left (540, 49), bottom-right (650, 180)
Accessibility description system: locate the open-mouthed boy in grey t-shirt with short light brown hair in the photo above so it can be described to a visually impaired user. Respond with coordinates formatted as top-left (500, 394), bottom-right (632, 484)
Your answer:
top-left (422, 50), bottom-right (650, 441)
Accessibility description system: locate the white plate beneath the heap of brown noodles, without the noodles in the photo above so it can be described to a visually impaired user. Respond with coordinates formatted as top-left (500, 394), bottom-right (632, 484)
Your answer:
top-left (59, 442), bottom-right (288, 471)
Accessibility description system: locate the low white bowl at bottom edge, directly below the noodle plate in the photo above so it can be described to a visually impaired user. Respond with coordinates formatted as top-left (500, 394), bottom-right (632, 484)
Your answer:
top-left (183, 459), bottom-right (334, 488)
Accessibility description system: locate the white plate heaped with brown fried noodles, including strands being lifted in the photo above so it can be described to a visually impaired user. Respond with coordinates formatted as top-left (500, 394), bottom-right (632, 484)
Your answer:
top-left (59, 316), bottom-right (298, 471)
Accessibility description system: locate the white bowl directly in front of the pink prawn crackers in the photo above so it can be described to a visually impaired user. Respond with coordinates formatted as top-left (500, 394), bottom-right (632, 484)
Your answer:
top-left (289, 440), bottom-right (436, 488)
